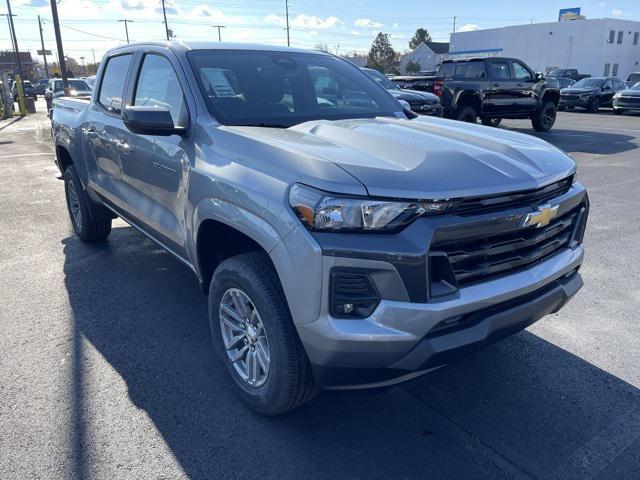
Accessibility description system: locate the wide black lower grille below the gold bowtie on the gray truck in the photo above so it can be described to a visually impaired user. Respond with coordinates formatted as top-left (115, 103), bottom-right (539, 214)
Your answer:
top-left (431, 208), bottom-right (580, 287)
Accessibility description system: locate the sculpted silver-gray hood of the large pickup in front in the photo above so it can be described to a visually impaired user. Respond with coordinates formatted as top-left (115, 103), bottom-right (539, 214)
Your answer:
top-left (226, 117), bottom-right (575, 199)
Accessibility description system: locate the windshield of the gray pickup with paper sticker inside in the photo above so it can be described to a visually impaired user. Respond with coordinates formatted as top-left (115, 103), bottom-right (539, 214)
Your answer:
top-left (188, 50), bottom-right (401, 127)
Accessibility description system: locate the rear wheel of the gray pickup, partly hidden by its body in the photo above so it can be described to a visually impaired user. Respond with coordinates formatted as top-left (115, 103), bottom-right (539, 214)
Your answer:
top-left (64, 165), bottom-right (111, 242)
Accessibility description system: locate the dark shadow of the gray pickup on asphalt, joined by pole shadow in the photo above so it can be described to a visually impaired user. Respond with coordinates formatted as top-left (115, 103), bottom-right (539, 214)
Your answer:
top-left (63, 227), bottom-right (640, 479)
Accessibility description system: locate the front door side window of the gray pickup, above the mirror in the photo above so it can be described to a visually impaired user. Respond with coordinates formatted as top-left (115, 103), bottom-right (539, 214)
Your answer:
top-left (133, 54), bottom-right (188, 127)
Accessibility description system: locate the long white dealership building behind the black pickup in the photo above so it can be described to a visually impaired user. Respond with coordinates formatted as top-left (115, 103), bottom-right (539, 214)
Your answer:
top-left (449, 17), bottom-right (640, 80)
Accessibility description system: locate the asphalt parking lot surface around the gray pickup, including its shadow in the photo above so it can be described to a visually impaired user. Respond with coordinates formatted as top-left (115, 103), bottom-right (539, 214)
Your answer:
top-left (0, 101), bottom-right (640, 480)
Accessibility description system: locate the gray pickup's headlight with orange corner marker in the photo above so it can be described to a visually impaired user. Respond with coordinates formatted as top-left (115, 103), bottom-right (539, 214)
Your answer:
top-left (289, 184), bottom-right (452, 231)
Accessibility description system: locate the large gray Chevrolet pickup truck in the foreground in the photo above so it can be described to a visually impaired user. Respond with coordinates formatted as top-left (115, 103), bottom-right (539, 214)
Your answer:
top-left (52, 42), bottom-right (589, 415)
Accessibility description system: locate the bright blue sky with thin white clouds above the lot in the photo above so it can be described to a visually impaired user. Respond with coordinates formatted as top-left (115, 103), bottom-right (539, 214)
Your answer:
top-left (0, 0), bottom-right (640, 62)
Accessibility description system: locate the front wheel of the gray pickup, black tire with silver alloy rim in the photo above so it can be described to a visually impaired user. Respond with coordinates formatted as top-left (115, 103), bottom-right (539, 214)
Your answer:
top-left (209, 252), bottom-right (317, 415)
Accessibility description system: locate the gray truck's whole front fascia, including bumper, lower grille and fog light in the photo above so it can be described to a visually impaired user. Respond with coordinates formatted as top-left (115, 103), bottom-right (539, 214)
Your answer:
top-left (297, 184), bottom-right (588, 389)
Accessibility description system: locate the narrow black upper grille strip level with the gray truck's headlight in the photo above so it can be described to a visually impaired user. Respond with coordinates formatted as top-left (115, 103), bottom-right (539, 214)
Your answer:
top-left (455, 176), bottom-right (573, 214)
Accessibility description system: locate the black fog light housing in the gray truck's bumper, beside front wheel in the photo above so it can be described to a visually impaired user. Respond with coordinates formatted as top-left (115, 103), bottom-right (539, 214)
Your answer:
top-left (329, 268), bottom-right (380, 319)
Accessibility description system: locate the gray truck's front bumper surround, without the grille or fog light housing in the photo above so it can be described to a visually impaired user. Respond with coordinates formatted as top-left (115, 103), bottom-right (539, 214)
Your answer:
top-left (297, 184), bottom-right (588, 389)
